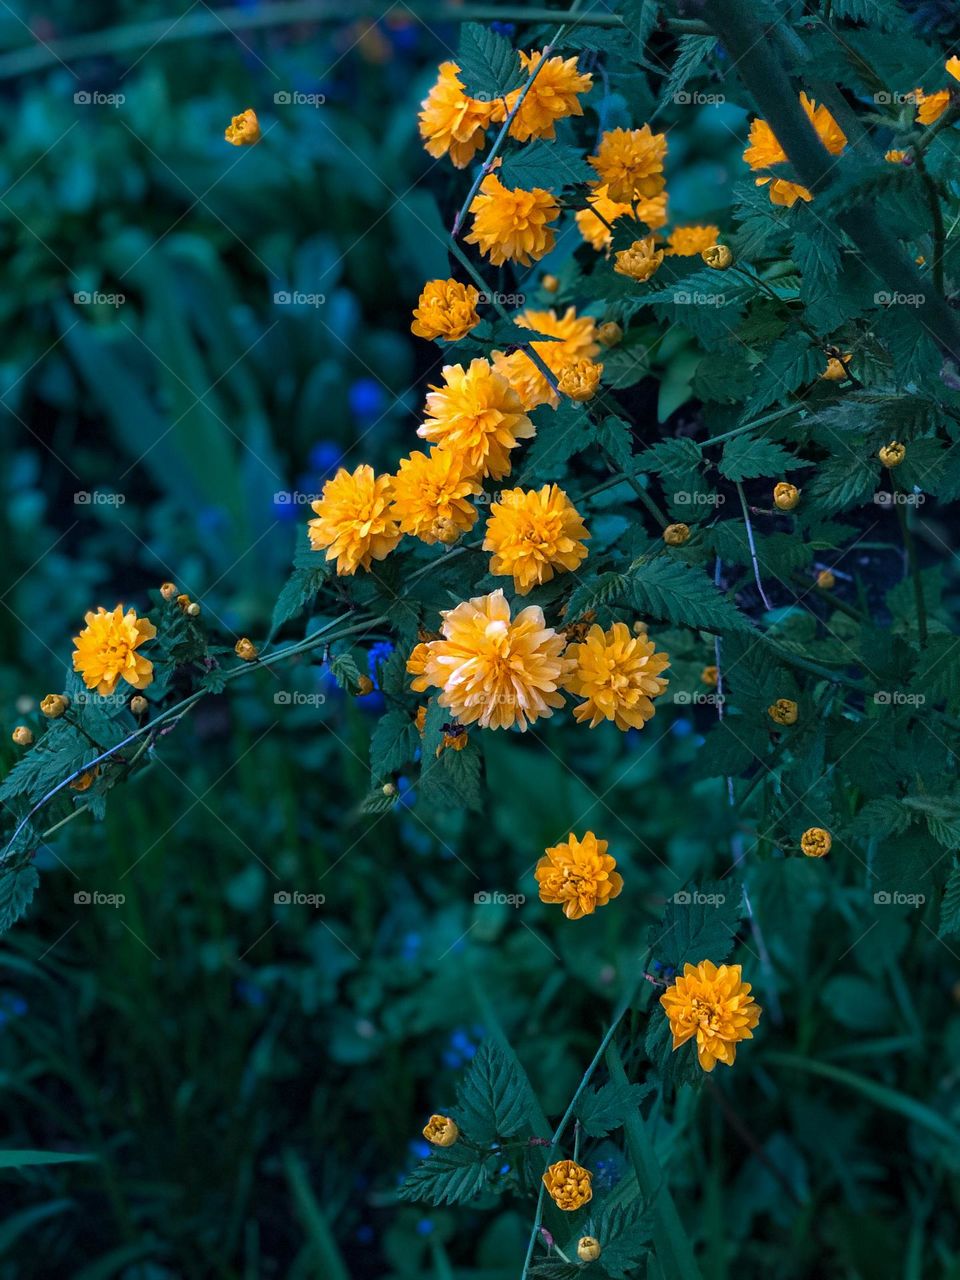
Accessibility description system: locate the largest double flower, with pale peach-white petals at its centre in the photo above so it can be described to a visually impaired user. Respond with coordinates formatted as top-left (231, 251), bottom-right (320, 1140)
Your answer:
top-left (407, 590), bottom-right (567, 731)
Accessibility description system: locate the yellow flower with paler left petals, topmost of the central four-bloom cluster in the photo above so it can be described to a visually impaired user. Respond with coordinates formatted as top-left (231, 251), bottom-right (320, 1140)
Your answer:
top-left (417, 360), bottom-right (536, 480)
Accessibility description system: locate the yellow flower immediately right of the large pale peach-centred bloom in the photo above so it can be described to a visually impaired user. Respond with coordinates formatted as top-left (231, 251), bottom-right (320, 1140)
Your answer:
top-left (563, 622), bottom-right (669, 732)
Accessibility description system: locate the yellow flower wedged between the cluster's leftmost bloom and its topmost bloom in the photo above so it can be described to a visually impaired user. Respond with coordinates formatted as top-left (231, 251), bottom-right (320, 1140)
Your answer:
top-left (392, 449), bottom-right (480, 544)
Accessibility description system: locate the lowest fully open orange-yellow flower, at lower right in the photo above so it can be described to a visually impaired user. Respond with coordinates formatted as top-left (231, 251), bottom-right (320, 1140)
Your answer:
top-left (660, 960), bottom-right (763, 1071)
